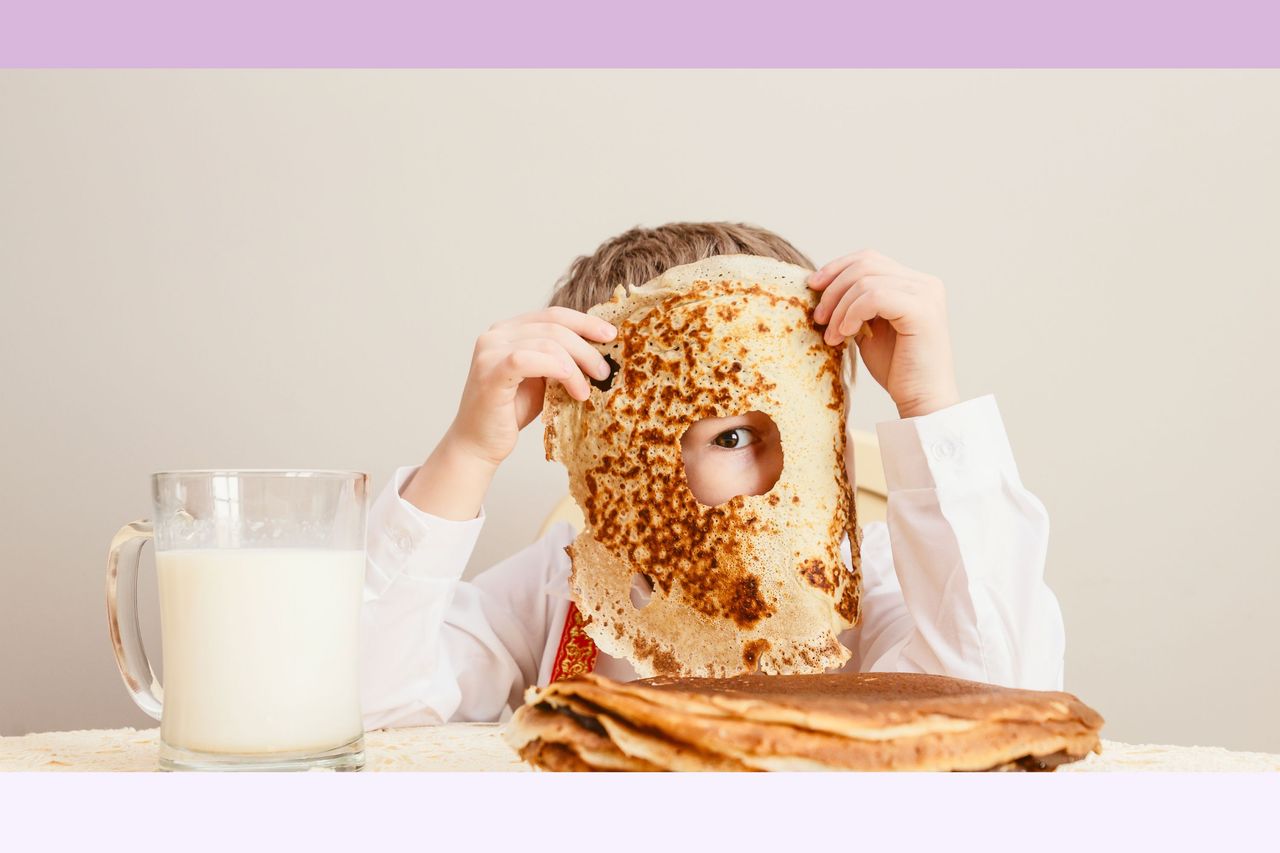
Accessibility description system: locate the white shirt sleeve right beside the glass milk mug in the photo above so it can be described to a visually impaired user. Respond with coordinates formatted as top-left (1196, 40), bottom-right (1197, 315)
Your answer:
top-left (360, 467), bottom-right (553, 729)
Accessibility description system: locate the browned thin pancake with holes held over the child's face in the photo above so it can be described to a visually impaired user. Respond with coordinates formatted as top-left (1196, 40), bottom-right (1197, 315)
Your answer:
top-left (543, 249), bottom-right (860, 678)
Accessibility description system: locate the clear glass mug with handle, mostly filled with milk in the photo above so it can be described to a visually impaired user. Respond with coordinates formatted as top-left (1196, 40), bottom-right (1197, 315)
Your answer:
top-left (106, 470), bottom-right (369, 770)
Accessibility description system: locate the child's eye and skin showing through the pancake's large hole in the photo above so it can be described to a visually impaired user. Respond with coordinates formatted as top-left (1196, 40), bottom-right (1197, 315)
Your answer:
top-left (680, 411), bottom-right (782, 506)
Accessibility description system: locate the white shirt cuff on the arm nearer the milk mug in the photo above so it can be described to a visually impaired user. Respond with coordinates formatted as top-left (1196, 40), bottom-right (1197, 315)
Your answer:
top-left (369, 466), bottom-right (484, 588)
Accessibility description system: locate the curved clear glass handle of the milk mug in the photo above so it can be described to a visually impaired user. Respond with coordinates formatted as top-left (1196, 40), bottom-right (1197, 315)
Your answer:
top-left (106, 519), bottom-right (164, 720)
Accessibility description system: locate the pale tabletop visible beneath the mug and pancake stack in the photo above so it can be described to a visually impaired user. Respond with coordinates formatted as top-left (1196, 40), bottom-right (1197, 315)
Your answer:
top-left (0, 722), bottom-right (1280, 772)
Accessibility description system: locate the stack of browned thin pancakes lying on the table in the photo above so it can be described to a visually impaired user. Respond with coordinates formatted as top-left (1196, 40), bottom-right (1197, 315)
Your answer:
top-left (506, 672), bottom-right (1102, 771)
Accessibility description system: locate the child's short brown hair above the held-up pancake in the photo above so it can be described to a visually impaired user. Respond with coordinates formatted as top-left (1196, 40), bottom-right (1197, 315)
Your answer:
top-left (550, 222), bottom-right (813, 311)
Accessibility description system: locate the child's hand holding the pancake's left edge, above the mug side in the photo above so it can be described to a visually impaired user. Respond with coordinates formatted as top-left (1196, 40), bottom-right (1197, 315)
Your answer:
top-left (445, 307), bottom-right (617, 466)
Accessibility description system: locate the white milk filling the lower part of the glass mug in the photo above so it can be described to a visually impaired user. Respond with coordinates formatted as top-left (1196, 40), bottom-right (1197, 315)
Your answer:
top-left (156, 548), bottom-right (365, 753)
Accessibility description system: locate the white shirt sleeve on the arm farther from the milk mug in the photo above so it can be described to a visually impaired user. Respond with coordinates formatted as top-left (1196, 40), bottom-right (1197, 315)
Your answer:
top-left (856, 396), bottom-right (1065, 690)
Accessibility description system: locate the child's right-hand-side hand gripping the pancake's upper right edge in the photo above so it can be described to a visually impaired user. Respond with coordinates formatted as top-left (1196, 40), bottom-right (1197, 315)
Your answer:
top-left (809, 250), bottom-right (960, 418)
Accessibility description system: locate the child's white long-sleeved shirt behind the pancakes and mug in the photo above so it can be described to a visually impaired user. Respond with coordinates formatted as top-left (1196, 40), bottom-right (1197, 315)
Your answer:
top-left (361, 396), bottom-right (1065, 729)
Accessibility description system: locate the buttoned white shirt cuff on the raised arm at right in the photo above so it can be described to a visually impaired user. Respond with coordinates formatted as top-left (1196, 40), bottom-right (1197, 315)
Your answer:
top-left (876, 394), bottom-right (1020, 492)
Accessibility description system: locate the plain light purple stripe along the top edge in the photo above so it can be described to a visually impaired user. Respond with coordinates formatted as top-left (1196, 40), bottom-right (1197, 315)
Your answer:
top-left (0, 0), bottom-right (1280, 68)
